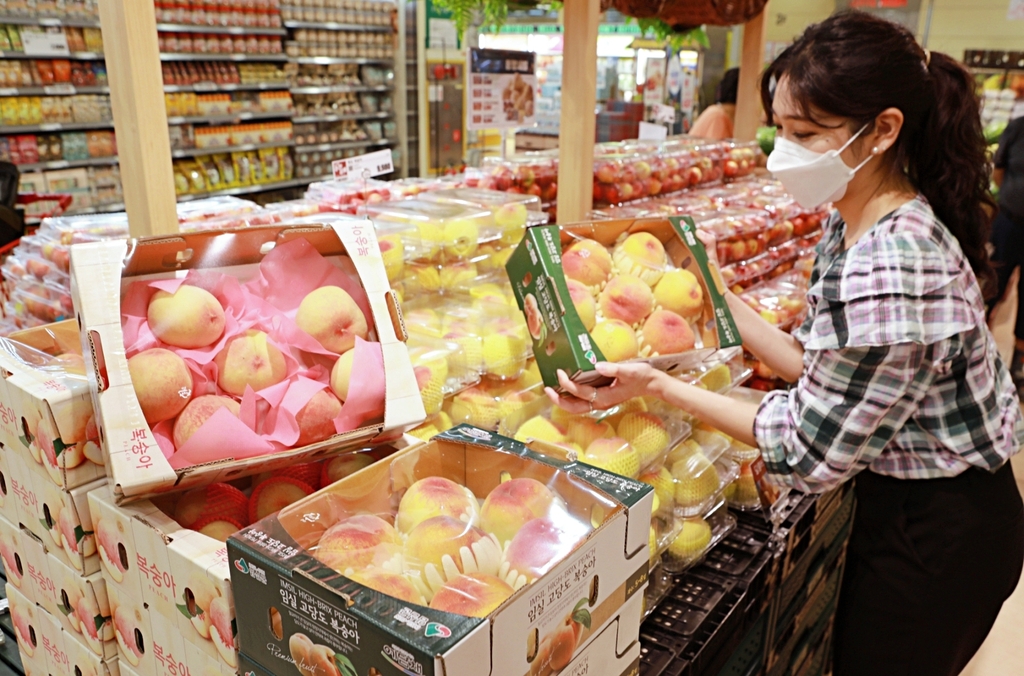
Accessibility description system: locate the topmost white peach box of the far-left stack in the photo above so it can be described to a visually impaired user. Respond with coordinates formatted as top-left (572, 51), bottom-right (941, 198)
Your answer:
top-left (0, 320), bottom-right (106, 490)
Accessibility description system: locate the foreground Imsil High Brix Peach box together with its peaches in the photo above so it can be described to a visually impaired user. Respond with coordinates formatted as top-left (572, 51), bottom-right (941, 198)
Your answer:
top-left (228, 426), bottom-right (651, 676)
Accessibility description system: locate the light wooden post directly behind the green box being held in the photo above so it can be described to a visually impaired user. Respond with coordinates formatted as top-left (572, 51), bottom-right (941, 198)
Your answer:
top-left (558, 0), bottom-right (601, 223)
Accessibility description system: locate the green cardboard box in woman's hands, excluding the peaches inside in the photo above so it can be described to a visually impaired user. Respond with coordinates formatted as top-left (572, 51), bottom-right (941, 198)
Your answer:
top-left (506, 217), bottom-right (741, 389)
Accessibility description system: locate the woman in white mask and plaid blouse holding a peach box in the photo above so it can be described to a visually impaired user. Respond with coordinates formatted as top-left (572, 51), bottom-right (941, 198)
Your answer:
top-left (549, 12), bottom-right (1024, 676)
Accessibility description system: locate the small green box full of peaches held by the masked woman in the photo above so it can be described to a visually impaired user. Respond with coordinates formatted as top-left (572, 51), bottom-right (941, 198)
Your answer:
top-left (506, 218), bottom-right (739, 387)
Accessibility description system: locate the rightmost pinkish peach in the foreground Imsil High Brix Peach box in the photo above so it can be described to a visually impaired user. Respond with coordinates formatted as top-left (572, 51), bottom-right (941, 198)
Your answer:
top-left (502, 517), bottom-right (587, 589)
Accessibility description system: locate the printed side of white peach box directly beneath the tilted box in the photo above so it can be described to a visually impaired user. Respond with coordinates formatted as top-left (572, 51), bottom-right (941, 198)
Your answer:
top-left (89, 488), bottom-right (238, 673)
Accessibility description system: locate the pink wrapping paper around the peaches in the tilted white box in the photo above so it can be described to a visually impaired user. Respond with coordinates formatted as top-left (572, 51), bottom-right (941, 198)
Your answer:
top-left (121, 234), bottom-right (385, 469)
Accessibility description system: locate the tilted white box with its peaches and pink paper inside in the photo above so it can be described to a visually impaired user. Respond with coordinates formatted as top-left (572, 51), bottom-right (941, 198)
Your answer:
top-left (71, 221), bottom-right (423, 498)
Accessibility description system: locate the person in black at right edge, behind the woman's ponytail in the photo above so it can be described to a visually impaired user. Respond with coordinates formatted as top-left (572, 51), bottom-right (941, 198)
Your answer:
top-left (989, 118), bottom-right (1024, 393)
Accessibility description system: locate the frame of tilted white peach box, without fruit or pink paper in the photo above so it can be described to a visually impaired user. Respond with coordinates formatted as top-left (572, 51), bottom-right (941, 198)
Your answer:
top-left (71, 221), bottom-right (425, 503)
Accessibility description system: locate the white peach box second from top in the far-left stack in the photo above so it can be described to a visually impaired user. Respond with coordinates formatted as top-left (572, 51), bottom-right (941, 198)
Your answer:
top-left (15, 454), bottom-right (106, 576)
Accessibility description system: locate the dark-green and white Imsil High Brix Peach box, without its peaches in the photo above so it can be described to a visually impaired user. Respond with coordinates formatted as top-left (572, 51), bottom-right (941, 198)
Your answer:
top-left (227, 425), bottom-right (653, 676)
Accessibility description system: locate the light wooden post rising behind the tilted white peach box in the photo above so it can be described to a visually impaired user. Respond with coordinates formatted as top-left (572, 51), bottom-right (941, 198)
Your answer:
top-left (99, 0), bottom-right (178, 237)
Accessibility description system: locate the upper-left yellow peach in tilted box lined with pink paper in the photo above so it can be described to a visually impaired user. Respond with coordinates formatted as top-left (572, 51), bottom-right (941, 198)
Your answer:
top-left (146, 284), bottom-right (224, 349)
